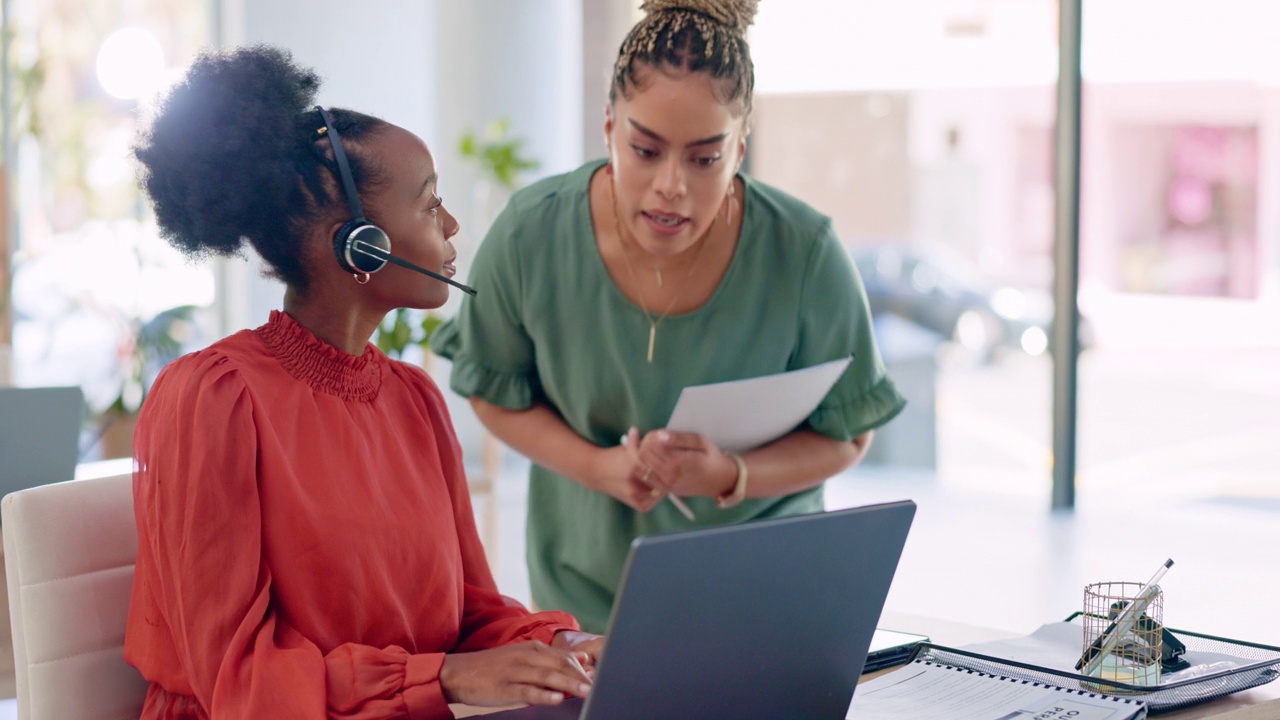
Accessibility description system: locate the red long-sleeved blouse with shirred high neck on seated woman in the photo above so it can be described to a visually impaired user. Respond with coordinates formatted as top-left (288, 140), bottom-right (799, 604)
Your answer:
top-left (124, 313), bottom-right (577, 719)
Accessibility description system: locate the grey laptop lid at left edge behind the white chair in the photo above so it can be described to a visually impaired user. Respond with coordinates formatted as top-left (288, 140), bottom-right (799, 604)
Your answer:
top-left (0, 387), bottom-right (84, 496)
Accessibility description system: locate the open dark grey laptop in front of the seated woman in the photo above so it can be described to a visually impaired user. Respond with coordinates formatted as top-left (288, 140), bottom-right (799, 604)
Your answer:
top-left (488, 501), bottom-right (915, 720)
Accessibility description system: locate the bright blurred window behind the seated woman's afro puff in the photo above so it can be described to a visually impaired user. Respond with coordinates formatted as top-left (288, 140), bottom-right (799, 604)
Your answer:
top-left (5, 0), bottom-right (214, 459)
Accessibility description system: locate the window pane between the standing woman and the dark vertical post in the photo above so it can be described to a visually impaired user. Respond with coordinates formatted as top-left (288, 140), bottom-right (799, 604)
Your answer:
top-left (750, 0), bottom-right (1057, 486)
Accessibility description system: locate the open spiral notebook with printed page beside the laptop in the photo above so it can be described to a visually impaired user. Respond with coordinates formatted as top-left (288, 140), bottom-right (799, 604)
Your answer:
top-left (847, 660), bottom-right (1147, 720)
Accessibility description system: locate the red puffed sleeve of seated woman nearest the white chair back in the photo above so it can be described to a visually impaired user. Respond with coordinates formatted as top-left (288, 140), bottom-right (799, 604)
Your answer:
top-left (125, 352), bottom-right (452, 720)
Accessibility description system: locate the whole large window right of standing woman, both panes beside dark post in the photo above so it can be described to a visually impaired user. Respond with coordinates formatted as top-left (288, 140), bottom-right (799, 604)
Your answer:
top-left (750, 0), bottom-right (1280, 502)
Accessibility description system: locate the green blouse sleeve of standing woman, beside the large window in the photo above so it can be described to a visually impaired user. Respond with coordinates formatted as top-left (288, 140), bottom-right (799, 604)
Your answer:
top-left (795, 222), bottom-right (906, 441)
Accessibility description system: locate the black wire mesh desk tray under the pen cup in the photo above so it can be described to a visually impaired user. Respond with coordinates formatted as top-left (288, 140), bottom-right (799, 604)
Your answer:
top-left (909, 612), bottom-right (1280, 715)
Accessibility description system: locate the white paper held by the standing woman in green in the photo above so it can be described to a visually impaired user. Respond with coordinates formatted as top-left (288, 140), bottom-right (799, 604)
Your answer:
top-left (667, 357), bottom-right (852, 452)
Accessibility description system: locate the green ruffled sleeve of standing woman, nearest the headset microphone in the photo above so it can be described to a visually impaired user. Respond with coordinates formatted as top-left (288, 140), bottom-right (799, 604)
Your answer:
top-left (431, 202), bottom-right (538, 410)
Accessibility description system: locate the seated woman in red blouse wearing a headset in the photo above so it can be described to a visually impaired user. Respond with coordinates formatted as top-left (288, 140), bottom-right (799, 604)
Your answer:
top-left (124, 46), bottom-right (603, 719)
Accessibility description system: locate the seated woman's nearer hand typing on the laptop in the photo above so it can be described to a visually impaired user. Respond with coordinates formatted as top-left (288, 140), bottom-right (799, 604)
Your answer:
top-left (440, 633), bottom-right (594, 707)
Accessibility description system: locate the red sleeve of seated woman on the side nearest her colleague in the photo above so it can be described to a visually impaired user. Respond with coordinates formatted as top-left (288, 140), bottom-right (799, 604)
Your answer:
top-left (397, 364), bottom-right (579, 652)
